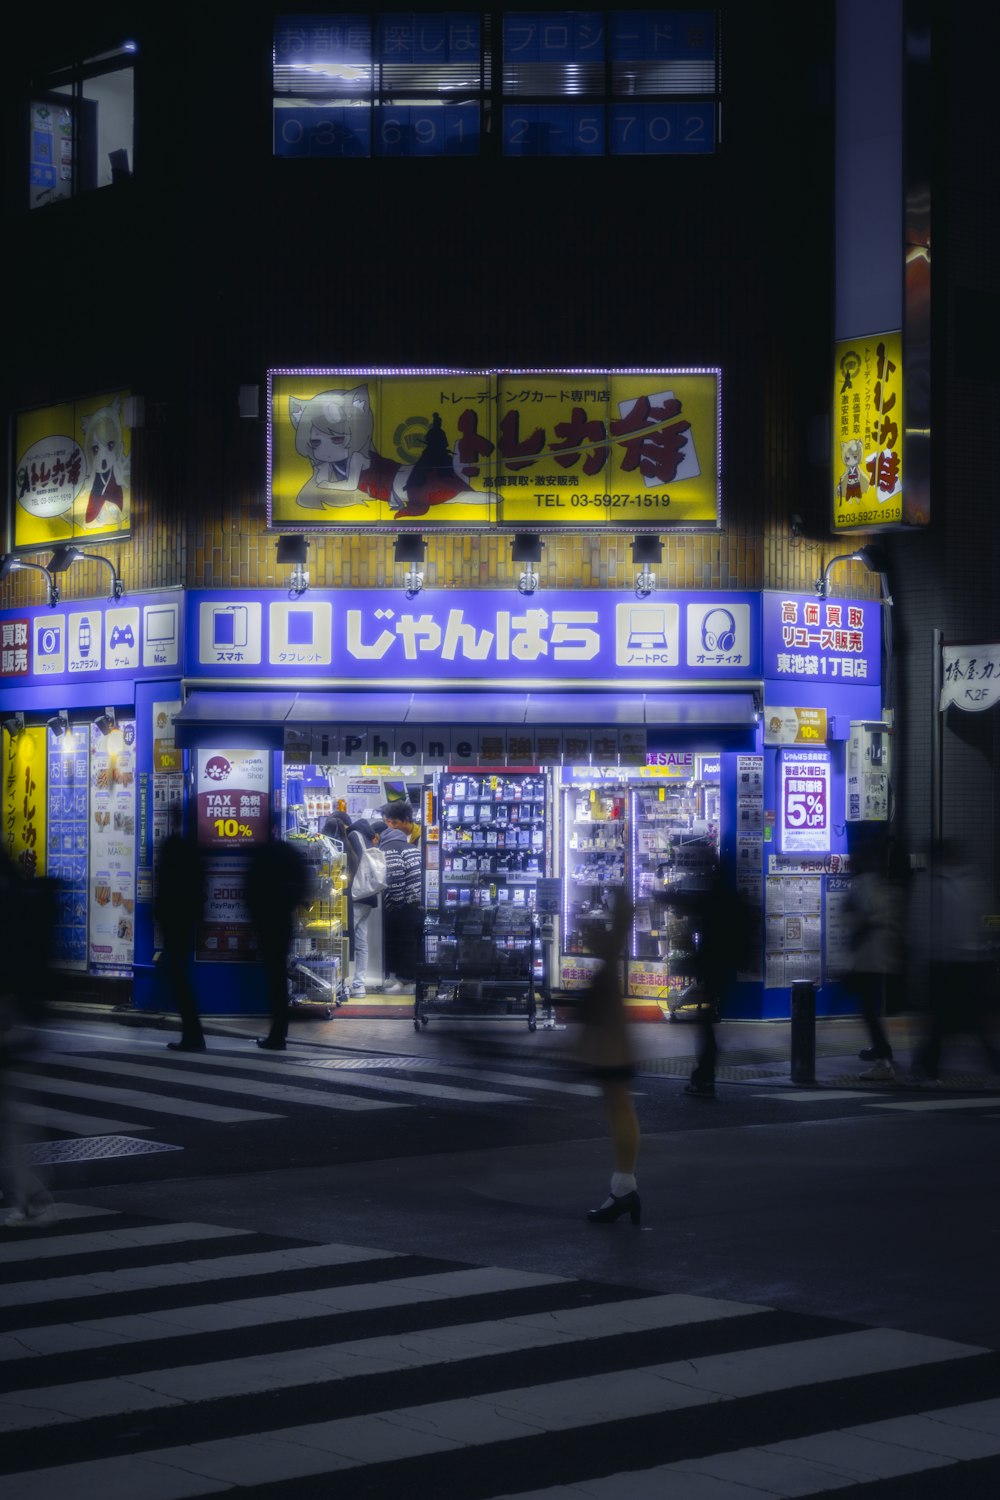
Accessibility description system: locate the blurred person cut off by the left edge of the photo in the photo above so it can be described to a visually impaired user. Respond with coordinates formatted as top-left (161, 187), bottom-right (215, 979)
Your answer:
top-left (0, 849), bottom-right (57, 1229)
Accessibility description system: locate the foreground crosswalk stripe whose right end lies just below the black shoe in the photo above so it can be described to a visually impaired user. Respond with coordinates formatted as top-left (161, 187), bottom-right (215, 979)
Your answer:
top-left (0, 1266), bottom-right (565, 1361)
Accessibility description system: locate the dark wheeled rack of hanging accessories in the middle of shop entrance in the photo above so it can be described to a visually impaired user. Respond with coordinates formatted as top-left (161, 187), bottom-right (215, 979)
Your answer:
top-left (414, 771), bottom-right (550, 1029)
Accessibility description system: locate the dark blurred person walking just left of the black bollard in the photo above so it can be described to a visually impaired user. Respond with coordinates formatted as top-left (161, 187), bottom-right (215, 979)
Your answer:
top-left (666, 851), bottom-right (759, 1100)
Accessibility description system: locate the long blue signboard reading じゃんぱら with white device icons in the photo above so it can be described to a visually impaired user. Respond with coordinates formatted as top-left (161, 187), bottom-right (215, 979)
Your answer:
top-left (184, 588), bottom-right (760, 687)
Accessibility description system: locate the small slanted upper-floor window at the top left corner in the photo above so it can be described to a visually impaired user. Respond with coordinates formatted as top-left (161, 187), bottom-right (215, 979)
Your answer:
top-left (28, 42), bottom-right (135, 209)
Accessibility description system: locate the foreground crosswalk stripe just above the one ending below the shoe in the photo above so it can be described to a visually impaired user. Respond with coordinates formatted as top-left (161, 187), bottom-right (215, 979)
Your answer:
top-left (0, 1236), bottom-right (400, 1308)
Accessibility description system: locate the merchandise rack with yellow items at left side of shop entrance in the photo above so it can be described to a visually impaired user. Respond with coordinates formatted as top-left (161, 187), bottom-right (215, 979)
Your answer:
top-left (288, 834), bottom-right (348, 1016)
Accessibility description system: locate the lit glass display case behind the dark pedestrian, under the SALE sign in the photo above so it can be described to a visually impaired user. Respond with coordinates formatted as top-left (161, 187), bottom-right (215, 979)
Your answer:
top-left (628, 776), bottom-right (718, 1019)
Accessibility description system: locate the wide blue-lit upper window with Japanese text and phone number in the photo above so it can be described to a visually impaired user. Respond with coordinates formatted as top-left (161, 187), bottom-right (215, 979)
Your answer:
top-left (273, 8), bottom-right (720, 156)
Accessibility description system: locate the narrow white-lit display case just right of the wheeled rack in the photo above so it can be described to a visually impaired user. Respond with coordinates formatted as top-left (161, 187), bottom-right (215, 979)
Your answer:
top-left (561, 783), bottom-right (628, 989)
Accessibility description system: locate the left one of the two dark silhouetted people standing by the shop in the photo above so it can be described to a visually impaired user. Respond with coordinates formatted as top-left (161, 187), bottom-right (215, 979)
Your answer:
top-left (153, 807), bottom-right (205, 1052)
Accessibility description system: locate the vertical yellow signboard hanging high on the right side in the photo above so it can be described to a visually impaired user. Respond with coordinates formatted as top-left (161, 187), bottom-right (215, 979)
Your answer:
top-left (832, 333), bottom-right (904, 531)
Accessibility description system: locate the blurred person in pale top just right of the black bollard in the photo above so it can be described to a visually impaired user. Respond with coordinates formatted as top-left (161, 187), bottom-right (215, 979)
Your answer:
top-left (846, 824), bottom-right (906, 1082)
